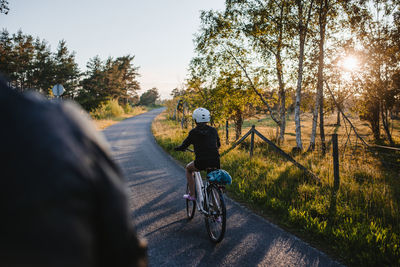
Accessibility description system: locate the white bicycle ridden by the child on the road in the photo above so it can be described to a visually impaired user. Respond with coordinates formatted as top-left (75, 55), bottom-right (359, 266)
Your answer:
top-left (186, 164), bottom-right (226, 243)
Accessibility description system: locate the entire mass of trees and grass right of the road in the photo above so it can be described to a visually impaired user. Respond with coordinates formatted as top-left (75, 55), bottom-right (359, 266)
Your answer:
top-left (153, 0), bottom-right (400, 266)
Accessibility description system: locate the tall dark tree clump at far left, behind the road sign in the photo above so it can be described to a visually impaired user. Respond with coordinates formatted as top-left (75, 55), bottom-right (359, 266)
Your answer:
top-left (0, 30), bottom-right (80, 94)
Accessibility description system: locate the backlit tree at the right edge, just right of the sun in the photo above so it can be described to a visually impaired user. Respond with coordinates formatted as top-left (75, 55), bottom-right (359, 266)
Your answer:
top-left (346, 0), bottom-right (400, 145)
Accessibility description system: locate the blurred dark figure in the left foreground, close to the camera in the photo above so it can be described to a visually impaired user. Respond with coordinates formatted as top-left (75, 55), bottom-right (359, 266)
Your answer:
top-left (0, 81), bottom-right (147, 267)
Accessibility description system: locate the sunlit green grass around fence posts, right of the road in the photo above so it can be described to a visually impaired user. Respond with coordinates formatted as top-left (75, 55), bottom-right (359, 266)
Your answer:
top-left (153, 112), bottom-right (400, 266)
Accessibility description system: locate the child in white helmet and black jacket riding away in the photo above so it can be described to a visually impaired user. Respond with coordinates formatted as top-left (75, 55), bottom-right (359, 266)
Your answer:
top-left (175, 108), bottom-right (221, 200)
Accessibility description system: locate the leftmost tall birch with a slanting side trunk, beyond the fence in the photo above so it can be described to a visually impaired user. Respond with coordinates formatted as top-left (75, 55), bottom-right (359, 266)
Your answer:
top-left (203, 0), bottom-right (289, 142)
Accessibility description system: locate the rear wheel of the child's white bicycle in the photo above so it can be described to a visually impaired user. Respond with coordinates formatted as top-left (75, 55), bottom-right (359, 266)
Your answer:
top-left (205, 184), bottom-right (226, 243)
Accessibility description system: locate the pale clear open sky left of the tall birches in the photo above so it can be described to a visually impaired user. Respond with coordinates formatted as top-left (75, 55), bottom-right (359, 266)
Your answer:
top-left (0, 0), bottom-right (225, 99)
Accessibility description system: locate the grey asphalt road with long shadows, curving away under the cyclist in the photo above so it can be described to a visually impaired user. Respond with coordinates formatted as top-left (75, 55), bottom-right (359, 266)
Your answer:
top-left (103, 109), bottom-right (341, 267)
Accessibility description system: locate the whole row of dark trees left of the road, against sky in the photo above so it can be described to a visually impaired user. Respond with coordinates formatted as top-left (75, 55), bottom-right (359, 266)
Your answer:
top-left (0, 30), bottom-right (140, 111)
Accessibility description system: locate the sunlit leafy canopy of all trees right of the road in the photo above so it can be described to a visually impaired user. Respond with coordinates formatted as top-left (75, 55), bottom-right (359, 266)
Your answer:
top-left (178, 0), bottom-right (400, 151)
